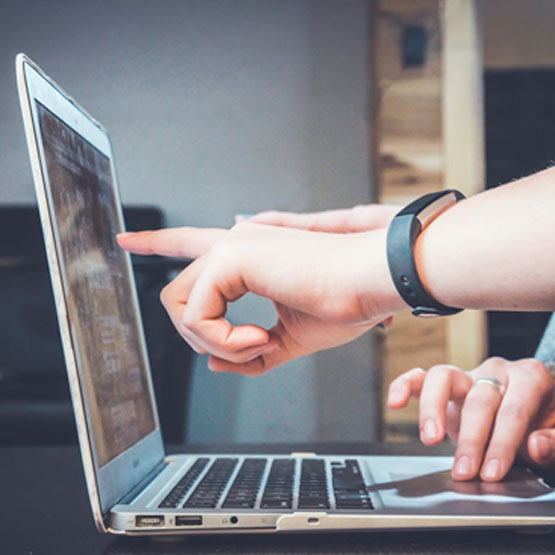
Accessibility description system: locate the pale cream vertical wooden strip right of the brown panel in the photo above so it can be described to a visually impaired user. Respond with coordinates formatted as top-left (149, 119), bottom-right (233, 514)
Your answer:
top-left (443, 0), bottom-right (487, 369)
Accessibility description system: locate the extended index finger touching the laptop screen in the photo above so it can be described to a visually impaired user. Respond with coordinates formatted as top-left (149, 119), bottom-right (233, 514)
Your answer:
top-left (117, 227), bottom-right (229, 258)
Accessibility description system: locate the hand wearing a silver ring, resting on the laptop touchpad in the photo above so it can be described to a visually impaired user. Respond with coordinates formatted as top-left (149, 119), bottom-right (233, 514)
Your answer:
top-left (387, 358), bottom-right (555, 481)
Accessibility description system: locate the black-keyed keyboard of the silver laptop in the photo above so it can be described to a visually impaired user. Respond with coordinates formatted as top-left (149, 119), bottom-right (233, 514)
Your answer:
top-left (159, 457), bottom-right (374, 511)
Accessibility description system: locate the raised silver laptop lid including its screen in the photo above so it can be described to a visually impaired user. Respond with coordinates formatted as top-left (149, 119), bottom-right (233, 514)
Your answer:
top-left (16, 54), bottom-right (164, 527)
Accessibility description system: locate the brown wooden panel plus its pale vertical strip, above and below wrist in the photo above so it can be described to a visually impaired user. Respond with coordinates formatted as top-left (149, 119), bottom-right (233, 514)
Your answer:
top-left (371, 0), bottom-right (485, 439)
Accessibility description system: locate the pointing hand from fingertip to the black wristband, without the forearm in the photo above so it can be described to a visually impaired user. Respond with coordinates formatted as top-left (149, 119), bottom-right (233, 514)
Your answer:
top-left (118, 222), bottom-right (404, 376)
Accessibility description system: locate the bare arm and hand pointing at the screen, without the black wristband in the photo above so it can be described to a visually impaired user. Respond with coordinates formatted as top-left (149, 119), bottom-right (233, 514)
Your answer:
top-left (118, 169), bottom-right (555, 373)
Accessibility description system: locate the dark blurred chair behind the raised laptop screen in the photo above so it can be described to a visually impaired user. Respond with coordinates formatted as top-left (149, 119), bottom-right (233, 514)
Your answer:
top-left (0, 206), bottom-right (192, 445)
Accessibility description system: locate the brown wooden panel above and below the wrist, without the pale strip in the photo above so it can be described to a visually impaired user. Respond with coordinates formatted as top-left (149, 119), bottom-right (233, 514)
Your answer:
top-left (372, 0), bottom-right (447, 440)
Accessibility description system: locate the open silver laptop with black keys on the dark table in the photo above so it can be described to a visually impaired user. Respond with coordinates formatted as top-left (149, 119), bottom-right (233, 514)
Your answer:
top-left (16, 54), bottom-right (555, 536)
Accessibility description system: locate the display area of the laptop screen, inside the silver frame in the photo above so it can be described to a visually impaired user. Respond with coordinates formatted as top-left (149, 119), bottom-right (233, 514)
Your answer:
top-left (37, 102), bottom-right (156, 467)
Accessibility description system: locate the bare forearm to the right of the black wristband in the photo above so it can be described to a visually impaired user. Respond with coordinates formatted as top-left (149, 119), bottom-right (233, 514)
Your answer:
top-left (415, 168), bottom-right (555, 310)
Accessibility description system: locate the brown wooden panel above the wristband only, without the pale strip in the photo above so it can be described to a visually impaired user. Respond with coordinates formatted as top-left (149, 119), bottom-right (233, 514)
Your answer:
top-left (372, 0), bottom-right (443, 204)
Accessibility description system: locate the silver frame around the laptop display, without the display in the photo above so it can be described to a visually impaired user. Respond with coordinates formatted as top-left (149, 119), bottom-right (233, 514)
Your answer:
top-left (16, 55), bottom-right (164, 524)
